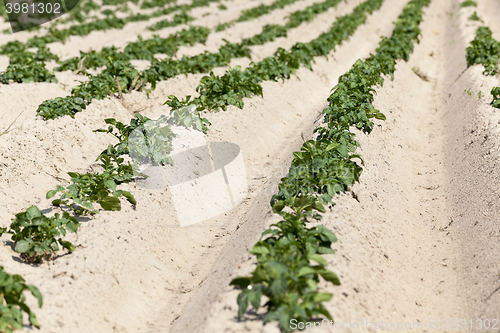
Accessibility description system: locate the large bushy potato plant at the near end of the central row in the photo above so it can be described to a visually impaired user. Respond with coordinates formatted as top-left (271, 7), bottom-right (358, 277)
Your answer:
top-left (231, 208), bottom-right (340, 332)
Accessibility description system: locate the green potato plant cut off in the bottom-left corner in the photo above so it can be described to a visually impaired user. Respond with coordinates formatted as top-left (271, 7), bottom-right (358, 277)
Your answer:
top-left (0, 266), bottom-right (43, 333)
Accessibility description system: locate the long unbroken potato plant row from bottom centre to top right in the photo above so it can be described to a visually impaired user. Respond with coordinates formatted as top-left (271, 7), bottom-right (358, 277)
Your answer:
top-left (231, 0), bottom-right (430, 332)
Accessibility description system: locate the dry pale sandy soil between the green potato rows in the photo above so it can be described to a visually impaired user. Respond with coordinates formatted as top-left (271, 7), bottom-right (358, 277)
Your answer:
top-left (0, 0), bottom-right (500, 332)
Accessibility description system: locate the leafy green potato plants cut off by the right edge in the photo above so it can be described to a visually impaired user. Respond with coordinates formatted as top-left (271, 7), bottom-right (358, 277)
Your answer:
top-left (466, 26), bottom-right (500, 109)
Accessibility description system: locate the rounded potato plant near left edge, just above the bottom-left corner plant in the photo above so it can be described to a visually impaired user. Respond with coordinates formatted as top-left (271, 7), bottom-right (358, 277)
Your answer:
top-left (2, 206), bottom-right (80, 263)
